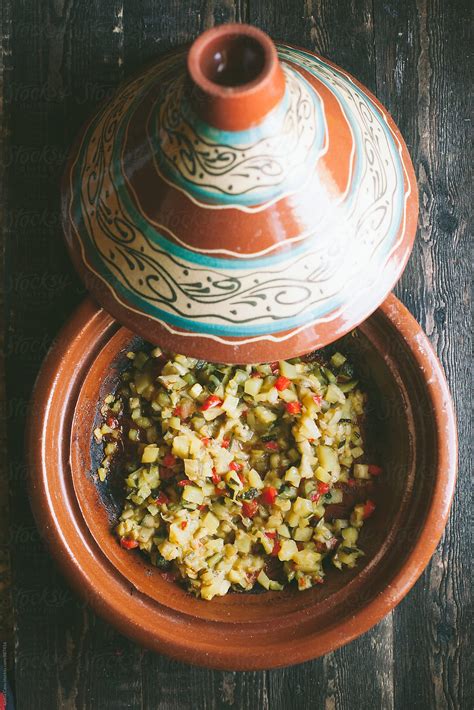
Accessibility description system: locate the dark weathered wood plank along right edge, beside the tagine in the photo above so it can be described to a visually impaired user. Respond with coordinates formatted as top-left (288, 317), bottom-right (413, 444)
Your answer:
top-left (375, 0), bottom-right (472, 709)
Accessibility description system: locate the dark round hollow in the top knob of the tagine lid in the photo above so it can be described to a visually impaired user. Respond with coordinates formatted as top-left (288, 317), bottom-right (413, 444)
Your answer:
top-left (200, 34), bottom-right (265, 87)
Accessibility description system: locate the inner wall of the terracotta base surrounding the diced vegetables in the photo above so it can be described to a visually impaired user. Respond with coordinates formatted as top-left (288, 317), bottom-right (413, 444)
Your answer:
top-left (70, 316), bottom-right (430, 624)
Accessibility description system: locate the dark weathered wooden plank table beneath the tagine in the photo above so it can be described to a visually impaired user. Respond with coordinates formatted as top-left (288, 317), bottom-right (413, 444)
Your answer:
top-left (0, 0), bottom-right (473, 710)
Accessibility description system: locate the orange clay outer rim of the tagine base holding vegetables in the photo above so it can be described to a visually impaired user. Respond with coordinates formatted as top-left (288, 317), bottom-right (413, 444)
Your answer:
top-left (27, 295), bottom-right (457, 670)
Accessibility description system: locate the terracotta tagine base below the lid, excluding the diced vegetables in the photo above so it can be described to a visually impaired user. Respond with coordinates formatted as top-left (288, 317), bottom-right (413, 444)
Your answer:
top-left (27, 296), bottom-right (456, 670)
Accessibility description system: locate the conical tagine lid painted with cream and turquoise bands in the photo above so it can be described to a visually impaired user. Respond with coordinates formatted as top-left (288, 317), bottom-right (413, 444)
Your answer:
top-left (62, 25), bottom-right (418, 363)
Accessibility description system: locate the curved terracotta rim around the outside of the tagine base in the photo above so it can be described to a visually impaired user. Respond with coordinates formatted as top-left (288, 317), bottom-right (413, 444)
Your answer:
top-left (26, 294), bottom-right (457, 670)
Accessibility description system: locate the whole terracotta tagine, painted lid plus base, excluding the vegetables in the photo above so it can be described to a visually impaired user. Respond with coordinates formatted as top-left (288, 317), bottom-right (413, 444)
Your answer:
top-left (27, 25), bottom-right (456, 670)
